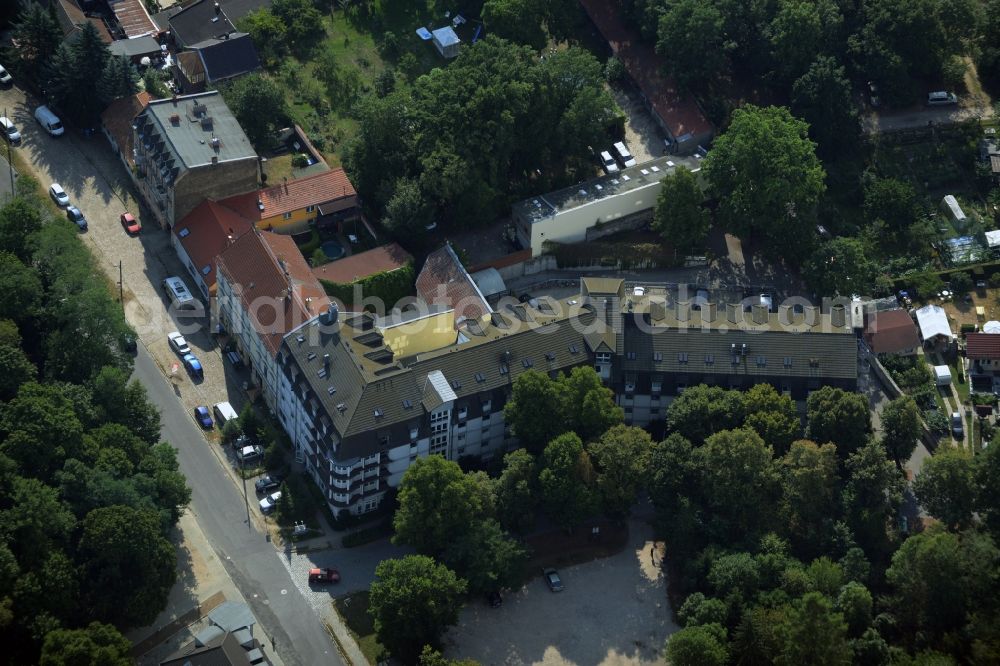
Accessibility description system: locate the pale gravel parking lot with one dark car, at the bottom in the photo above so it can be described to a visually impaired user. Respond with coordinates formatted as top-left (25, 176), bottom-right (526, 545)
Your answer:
top-left (446, 521), bottom-right (678, 666)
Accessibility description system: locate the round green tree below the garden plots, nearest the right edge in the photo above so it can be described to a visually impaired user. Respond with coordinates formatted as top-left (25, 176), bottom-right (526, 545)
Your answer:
top-left (913, 447), bottom-right (975, 529)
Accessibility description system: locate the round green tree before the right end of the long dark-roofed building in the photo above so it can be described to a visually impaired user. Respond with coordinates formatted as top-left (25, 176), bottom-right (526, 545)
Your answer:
top-left (806, 386), bottom-right (872, 458)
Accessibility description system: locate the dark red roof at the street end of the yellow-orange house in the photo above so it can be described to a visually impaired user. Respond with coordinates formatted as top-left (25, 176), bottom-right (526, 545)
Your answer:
top-left (173, 199), bottom-right (253, 291)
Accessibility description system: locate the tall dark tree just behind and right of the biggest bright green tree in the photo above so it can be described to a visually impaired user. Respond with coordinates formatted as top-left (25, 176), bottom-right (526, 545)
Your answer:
top-left (792, 56), bottom-right (861, 155)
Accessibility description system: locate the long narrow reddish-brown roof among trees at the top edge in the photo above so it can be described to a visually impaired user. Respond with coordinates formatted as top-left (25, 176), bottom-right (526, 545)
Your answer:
top-left (580, 0), bottom-right (712, 141)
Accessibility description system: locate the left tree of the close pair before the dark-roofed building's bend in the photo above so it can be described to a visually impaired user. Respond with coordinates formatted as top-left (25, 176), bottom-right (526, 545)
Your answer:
top-left (503, 370), bottom-right (569, 453)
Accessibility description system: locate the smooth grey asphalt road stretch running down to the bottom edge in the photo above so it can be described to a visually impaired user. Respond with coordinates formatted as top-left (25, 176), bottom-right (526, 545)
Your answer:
top-left (133, 346), bottom-right (344, 666)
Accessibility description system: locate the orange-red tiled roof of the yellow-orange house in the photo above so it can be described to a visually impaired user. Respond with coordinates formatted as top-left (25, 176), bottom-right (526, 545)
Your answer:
top-left (219, 169), bottom-right (357, 222)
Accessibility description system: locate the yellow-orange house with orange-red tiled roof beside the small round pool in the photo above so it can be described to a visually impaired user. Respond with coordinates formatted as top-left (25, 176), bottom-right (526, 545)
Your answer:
top-left (219, 169), bottom-right (361, 234)
